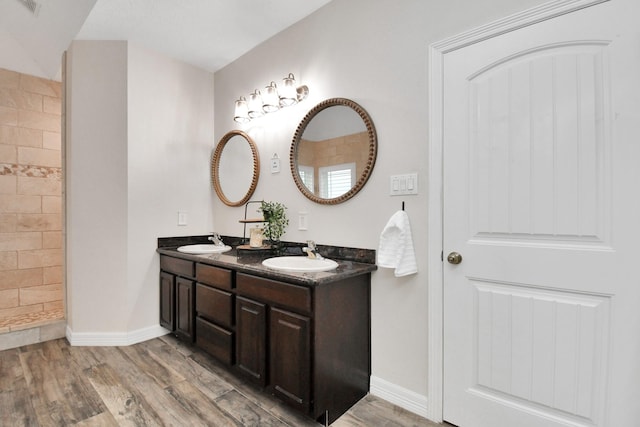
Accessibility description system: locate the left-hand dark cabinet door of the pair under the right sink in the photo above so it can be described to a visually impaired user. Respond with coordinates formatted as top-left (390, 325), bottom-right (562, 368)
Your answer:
top-left (236, 297), bottom-right (267, 387)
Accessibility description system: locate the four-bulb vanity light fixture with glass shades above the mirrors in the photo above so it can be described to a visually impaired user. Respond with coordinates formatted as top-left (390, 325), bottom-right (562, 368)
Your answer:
top-left (233, 73), bottom-right (309, 123)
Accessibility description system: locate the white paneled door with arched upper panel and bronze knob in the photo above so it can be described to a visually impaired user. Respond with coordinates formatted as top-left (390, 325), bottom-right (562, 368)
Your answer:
top-left (443, 0), bottom-right (640, 427)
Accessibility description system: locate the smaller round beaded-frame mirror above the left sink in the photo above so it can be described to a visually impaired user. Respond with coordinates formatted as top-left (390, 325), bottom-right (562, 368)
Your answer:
top-left (211, 130), bottom-right (260, 206)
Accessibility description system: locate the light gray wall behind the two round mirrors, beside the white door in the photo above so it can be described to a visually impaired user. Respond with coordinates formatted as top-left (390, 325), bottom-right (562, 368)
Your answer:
top-left (214, 0), bottom-right (542, 410)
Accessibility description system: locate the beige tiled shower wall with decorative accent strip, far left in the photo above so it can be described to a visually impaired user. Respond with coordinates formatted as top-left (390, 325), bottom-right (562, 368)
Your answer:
top-left (0, 69), bottom-right (64, 333)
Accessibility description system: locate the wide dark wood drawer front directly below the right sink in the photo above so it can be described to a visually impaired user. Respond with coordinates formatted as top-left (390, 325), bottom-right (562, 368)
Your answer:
top-left (236, 273), bottom-right (311, 314)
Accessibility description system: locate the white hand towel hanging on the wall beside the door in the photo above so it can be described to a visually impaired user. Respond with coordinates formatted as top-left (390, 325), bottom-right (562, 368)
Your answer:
top-left (378, 211), bottom-right (418, 277)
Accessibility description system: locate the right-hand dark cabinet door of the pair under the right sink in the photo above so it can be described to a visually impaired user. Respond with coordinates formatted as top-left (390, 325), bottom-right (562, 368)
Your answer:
top-left (269, 308), bottom-right (311, 413)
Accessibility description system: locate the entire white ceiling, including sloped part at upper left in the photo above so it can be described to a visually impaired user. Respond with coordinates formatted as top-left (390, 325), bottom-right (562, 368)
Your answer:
top-left (0, 0), bottom-right (330, 78)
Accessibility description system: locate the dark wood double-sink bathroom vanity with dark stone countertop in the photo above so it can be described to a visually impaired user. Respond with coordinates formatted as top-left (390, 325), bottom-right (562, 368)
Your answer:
top-left (158, 239), bottom-right (376, 423)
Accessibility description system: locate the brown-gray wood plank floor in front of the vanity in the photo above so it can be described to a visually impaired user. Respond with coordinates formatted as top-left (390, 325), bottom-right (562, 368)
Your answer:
top-left (0, 336), bottom-right (438, 427)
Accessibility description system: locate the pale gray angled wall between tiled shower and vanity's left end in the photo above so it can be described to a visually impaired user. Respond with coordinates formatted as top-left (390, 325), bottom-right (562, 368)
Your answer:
top-left (65, 41), bottom-right (214, 345)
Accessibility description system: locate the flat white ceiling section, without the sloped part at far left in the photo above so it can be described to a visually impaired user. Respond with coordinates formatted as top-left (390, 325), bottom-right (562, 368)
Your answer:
top-left (76, 0), bottom-right (330, 71)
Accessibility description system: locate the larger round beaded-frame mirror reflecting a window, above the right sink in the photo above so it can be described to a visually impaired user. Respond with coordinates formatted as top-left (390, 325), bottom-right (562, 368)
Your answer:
top-left (289, 98), bottom-right (378, 205)
